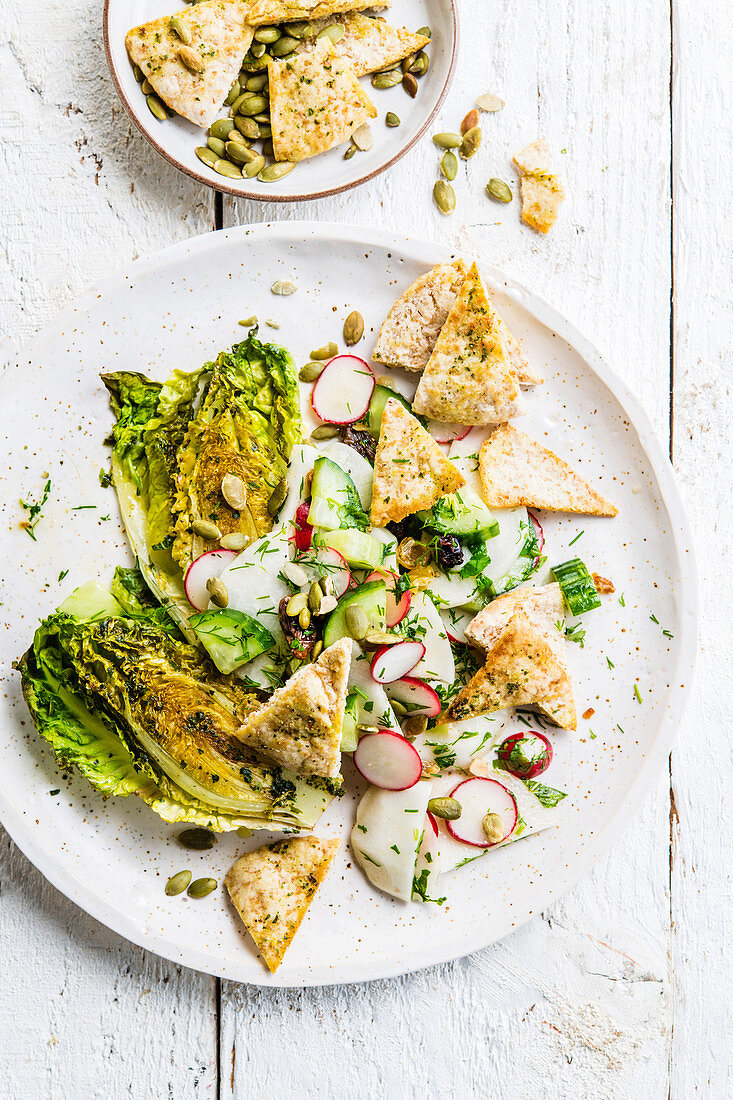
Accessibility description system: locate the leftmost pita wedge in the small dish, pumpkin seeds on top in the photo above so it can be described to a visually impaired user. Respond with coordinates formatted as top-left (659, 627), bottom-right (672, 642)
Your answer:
top-left (124, 0), bottom-right (254, 127)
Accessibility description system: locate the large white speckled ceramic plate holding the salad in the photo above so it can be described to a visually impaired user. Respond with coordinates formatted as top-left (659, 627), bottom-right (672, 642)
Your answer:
top-left (0, 223), bottom-right (696, 986)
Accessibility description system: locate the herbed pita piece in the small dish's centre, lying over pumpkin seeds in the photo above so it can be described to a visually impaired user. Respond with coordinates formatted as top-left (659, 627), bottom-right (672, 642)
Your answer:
top-left (267, 39), bottom-right (376, 161)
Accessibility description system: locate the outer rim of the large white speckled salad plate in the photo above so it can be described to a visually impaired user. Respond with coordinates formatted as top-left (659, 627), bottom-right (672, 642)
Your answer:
top-left (0, 220), bottom-right (700, 988)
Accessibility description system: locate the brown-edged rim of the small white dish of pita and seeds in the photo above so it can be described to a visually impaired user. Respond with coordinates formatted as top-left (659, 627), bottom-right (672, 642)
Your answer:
top-left (102, 0), bottom-right (460, 202)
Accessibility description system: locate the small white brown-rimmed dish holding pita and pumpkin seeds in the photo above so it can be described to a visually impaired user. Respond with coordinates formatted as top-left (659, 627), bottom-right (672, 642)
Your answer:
top-left (103, 0), bottom-right (458, 202)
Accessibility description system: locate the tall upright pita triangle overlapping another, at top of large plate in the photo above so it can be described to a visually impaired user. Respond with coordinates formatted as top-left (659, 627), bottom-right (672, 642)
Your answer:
top-left (413, 264), bottom-right (523, 425)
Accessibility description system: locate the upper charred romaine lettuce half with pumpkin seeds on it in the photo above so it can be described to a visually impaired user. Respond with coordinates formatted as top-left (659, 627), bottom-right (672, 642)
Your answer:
top-left (102, 330), bottom-right (300, 641)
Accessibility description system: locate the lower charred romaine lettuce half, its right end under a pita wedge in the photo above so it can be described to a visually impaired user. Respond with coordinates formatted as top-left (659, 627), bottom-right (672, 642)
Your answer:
top-left (19, 570), bottom-right (335, 831)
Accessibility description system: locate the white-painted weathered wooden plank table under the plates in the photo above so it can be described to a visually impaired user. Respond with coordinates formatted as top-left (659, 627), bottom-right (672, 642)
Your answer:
top-left (0, 0), bottom-right (733, 1100)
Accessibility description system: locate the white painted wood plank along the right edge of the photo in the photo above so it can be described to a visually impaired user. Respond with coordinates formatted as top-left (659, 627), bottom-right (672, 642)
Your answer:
top-left (670, 0), bottom-right (733, 1100)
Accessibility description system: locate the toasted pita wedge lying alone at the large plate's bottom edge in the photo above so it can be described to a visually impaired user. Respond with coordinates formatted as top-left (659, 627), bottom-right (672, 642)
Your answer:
top-left (225, 836), bottom-right (341, 974)
